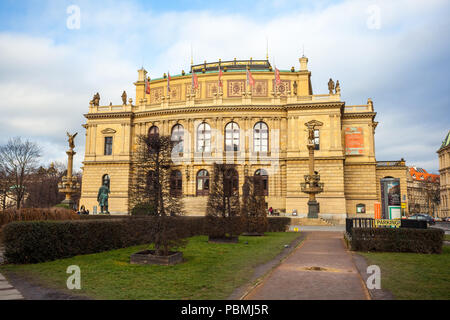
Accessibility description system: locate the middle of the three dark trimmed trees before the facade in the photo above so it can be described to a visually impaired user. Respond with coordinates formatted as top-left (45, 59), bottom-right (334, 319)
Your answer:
top-left (206, 163), bottom-right (242, 238)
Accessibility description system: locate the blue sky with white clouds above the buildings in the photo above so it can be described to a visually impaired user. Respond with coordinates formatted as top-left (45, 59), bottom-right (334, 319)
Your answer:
top-left (0, 0), bottom-right (450, 172)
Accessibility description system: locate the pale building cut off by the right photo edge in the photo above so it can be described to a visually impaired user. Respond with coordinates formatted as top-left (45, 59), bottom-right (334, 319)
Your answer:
top-left (438, 131), bottom-right (450, 217)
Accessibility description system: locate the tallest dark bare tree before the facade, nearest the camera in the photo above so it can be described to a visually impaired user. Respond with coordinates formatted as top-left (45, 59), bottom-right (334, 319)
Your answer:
top-left (129, 135), bottom-right (186, 255)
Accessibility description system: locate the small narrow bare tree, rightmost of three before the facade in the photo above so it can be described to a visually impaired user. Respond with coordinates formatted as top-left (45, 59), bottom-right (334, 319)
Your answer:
top-left (241, 177), bottom-right (268, 235)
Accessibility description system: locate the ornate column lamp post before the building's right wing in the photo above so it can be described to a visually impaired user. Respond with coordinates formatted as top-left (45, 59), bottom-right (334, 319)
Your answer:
top-left (300, 120), bottom-right (324, 218)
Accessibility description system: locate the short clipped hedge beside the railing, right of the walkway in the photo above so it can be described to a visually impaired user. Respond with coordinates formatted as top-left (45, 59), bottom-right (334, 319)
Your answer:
top-left (350, 228), bottom-right (445, 253)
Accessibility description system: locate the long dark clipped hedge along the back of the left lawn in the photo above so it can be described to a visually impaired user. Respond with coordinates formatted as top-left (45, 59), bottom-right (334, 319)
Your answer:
top-left (2, 216), bottom-right (289, 264)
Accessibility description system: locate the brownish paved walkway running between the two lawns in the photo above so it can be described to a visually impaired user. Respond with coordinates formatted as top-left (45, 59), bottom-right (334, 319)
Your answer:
top-left (245, 231), bottom-right (369, 300)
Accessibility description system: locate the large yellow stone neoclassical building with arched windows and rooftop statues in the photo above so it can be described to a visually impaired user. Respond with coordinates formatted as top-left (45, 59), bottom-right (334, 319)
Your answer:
top-left (80, 57), bottom-right (407, 219)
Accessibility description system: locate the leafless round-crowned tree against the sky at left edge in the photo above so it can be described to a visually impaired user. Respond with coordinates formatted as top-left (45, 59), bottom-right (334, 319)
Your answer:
top-left (0, 137), bottom-right (41, 209)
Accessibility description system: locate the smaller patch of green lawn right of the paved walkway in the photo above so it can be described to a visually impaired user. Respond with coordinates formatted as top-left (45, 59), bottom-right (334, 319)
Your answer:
top-left (359, 246), bottom-right (450, 300)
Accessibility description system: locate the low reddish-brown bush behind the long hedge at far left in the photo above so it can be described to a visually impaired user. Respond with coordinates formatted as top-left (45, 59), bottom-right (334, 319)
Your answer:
top-left (0, 208), bottom-right (80, 229)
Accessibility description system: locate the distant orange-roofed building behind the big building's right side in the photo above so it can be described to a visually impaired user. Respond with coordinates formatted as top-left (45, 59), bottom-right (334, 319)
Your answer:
top-left (407, 167), bottom-right (441, 217)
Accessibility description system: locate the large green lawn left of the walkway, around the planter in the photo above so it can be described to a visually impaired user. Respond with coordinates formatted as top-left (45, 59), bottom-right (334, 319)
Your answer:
top-left (0, 232), bottom-right (300, 299)
